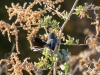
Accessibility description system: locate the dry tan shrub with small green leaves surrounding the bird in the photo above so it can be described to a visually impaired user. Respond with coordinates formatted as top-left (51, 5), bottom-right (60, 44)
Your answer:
top-left (0, 0), bottom-right (100, 75)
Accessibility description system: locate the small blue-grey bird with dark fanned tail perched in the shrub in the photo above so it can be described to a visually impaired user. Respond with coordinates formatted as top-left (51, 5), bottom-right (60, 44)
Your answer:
top-left (32, 32), bottom-right (58, 51)
